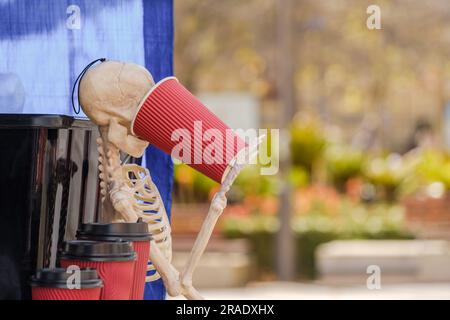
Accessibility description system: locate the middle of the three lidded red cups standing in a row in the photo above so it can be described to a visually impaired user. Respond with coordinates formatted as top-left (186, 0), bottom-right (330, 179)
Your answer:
top-left (60, 240), bottom-right (136, 300)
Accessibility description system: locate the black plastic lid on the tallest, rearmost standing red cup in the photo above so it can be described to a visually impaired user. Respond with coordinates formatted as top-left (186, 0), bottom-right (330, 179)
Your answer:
top-left (77, 219), bottom-right (152, 241)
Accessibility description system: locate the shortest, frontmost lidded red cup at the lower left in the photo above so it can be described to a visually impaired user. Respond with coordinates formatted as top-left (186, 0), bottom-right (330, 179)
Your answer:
top-left (30, 268), bottom-right (103, 300)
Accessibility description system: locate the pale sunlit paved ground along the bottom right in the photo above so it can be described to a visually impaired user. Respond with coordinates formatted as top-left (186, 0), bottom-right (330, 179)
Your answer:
top-left (169, 282), bottom-right (450, 300)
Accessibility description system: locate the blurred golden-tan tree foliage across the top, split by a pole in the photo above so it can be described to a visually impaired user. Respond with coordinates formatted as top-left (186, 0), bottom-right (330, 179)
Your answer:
top-left (175, 0), bottom-right (450, 151)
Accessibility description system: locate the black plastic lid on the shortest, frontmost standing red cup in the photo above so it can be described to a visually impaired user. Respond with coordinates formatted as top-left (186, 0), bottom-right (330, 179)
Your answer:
top-left (30, 268), bottom-right (103, 289)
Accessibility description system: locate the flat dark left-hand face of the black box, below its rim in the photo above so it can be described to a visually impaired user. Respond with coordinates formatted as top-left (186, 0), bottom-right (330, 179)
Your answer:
top-left (0, 129), bottom-right (40, 299)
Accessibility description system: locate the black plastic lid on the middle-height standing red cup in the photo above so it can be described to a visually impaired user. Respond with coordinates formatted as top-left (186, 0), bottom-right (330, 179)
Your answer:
top-left (61, 239), bottom-right (136, 261)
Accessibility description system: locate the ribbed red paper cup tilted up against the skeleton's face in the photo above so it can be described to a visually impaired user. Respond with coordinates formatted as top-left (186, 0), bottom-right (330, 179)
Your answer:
top-left (132, 77), bottom-right (245, 183)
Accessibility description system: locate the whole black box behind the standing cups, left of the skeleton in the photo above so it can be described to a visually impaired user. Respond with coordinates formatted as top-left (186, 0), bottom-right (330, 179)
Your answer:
top-left (0, 114), bottom-right (96, 300)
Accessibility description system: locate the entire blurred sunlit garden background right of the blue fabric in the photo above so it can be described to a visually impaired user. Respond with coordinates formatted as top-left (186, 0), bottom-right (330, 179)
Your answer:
top-left (172, 0), bottom-right (450, 299)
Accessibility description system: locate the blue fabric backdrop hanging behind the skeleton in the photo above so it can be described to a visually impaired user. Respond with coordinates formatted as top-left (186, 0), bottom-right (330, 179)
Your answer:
top-left (0, 0), bottom-right (173, 299)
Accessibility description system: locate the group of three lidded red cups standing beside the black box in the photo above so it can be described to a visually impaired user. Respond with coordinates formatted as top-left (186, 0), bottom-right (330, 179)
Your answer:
top-left (31, 221), bottom-right (151, 300)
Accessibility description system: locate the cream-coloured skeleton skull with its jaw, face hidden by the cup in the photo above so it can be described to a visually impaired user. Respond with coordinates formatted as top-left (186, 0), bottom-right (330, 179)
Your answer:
top-left (79, 61), bottom-right (155, 157)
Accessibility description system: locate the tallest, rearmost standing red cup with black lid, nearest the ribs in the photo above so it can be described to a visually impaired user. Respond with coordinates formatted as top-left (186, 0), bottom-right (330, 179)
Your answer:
top-left (77, 221), bottom-right (151, 300)
